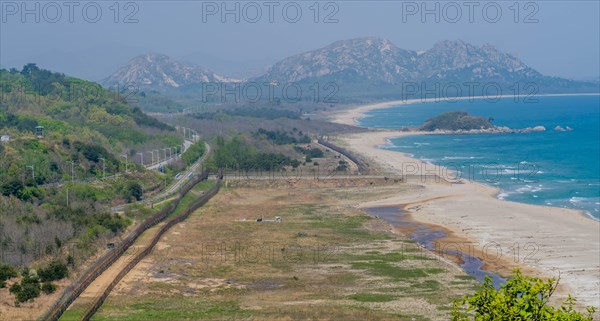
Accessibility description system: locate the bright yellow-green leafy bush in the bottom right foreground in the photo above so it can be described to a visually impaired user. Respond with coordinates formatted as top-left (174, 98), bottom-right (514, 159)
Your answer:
top-left (452, 269), bottom-right (596, 321)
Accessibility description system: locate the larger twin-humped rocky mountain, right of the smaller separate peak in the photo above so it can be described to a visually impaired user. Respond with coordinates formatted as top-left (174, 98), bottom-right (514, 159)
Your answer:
top-left (255, 38), bottom-right (541, 84)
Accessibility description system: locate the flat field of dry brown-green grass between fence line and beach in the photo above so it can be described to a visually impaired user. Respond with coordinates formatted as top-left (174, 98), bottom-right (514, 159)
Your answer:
top-left (74, 179), bottom-right (475, 320)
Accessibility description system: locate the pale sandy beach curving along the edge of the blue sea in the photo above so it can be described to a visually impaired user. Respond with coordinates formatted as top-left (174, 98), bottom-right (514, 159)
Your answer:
top-left (331, 99), bottom-right (600, 307)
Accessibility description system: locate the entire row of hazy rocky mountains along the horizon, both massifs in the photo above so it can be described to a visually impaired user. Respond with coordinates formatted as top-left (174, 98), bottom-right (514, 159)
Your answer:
top-left (103, 37), bottom-right (598, 96)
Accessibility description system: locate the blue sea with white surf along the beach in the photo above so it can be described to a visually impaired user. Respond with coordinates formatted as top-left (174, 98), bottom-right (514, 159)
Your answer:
top-left (360, 96), bottom-right (600, 219)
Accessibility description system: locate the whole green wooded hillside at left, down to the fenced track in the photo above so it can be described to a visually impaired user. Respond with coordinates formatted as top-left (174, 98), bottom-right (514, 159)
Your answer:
top-left (0, 64), bottom-right (183, 280)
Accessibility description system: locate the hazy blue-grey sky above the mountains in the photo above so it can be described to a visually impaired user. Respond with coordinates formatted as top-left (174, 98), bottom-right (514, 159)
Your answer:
top-left (0, 0), bottom-right (600, 79)
